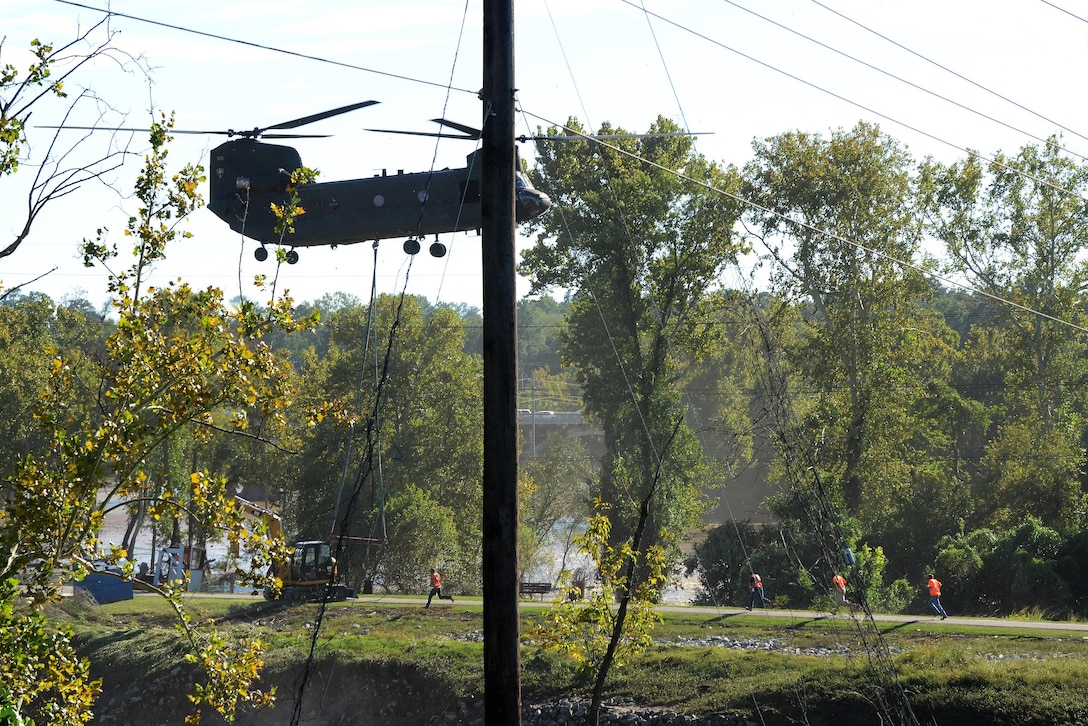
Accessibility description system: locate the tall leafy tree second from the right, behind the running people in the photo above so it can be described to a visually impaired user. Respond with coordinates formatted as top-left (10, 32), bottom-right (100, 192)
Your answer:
top-left (744, 123), bottom-right (967, 570)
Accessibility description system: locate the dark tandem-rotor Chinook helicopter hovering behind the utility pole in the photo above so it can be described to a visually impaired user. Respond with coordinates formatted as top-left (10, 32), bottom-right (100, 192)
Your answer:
top-left (206, 101), bottom-right (552, 264)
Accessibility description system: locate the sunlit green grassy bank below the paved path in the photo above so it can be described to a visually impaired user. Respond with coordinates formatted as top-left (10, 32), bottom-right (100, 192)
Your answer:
top-left (61, 598), bottom-right (1088, 726)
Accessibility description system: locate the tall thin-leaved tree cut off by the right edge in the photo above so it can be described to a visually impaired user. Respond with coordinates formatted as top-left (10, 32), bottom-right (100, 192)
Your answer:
top-left (923, 137), bottom-right (1088, 526)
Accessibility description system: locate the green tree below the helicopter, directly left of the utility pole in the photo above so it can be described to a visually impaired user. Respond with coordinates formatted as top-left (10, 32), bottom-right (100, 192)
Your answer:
top-left (292, 296), bottom-right (483, 591)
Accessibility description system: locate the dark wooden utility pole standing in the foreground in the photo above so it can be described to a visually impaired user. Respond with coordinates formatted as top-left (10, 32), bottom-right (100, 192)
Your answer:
top-left (480, 0), bottom-right (521, 726)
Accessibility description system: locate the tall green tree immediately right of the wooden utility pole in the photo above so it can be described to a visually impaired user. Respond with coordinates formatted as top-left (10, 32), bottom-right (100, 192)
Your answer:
top-left (521, 119), bottom-right (740, 586)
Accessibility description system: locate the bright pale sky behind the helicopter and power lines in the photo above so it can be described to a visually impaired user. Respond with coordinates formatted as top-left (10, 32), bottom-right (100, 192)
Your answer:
top-left (0, 0), bottom-right (1088, 308)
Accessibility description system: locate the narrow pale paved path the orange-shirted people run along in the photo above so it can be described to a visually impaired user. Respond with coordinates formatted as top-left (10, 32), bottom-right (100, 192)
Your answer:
top-left (193, 593), bottom-right (1088, 637)
